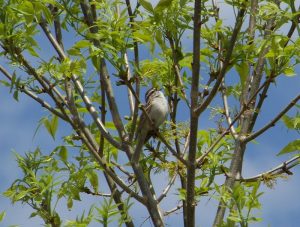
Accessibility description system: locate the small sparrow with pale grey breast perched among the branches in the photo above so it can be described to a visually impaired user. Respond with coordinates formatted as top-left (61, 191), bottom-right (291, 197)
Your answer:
top-left (132, 87), bottom-right (169, 162)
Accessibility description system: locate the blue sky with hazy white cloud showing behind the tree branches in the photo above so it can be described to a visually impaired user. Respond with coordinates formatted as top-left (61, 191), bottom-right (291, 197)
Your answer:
top-left (0, 0), bottom-right (300, 227)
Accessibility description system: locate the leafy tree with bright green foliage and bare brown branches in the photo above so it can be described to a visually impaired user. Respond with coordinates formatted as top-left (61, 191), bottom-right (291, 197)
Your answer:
top-left (0, 0), bottom-right (300, 227)
